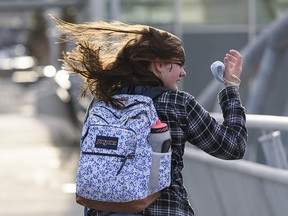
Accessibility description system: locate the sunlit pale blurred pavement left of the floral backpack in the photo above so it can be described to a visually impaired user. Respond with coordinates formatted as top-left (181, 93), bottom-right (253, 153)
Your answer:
top-left (0, 78), bottom-right (83, 216)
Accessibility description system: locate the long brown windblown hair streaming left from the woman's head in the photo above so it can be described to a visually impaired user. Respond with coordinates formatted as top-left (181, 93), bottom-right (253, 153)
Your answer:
top-left (52, 16), bottom-right (185, 106)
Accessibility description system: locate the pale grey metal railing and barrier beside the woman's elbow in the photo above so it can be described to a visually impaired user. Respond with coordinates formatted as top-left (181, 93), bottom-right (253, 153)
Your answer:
top-left (183, 113), bottom-right (288, 216)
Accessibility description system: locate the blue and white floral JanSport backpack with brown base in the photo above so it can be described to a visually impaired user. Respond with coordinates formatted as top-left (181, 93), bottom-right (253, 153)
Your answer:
top-left (76, 87), bottom-right (171, 212)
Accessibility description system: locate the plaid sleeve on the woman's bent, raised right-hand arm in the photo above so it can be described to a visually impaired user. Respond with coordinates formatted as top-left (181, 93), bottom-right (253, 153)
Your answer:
top-left (185, 86), bottom-right (247, 160)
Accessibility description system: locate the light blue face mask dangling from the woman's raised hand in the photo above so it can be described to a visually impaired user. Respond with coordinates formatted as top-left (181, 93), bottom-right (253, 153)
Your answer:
top-left (210, 61), bottom-right (241, 88)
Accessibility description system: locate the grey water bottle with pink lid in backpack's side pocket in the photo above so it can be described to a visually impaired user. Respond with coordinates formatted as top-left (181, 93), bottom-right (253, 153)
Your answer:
top-left (149, 120), bottom-right (171, 153)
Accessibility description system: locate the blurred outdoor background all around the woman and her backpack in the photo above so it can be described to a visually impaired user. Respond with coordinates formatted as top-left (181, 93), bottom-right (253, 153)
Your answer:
top-left (0, 0), bottom-right (288, 216)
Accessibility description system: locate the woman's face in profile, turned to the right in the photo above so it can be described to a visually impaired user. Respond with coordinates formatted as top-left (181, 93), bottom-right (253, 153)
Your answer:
top-left (157, 63), bottom-right (186, 90)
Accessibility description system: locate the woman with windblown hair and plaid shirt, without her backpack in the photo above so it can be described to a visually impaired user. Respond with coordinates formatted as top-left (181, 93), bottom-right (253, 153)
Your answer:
top-left (53, 16), bottom-right (247, 216)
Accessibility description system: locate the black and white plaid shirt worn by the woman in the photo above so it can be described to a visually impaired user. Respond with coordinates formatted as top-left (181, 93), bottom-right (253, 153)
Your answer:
top-left (90, 86), bottom-right (247, 216)
